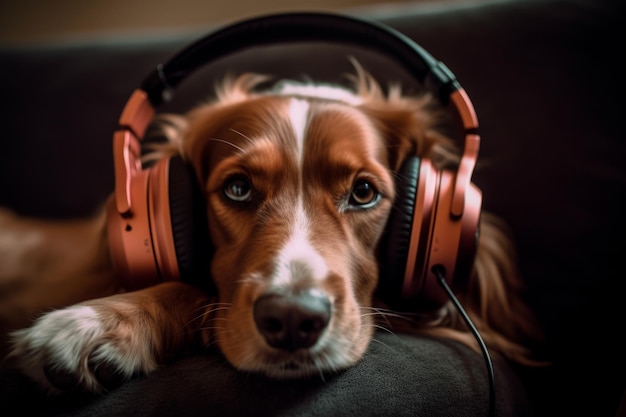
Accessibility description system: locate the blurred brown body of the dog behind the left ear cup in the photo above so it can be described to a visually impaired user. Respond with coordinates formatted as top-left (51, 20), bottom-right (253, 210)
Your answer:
top-left (0, 208), bottom-right (118, 332)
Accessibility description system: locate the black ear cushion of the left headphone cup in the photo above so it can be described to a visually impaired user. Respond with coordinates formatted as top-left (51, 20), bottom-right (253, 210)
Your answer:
top-left (168, 156), bottom-right (213, 291)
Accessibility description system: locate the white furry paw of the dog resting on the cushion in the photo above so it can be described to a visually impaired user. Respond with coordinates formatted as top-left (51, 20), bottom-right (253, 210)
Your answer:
top-left (10, 305), bottom-right (157, 393)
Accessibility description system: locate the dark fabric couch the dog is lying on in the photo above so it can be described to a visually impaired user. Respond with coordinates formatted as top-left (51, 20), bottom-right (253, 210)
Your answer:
top-left (0, 0), bottom-right (626, 417)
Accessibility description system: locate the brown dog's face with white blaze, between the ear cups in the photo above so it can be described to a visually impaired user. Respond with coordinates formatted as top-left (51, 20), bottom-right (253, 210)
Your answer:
top-left (163, 74), bottom-right (446, 377)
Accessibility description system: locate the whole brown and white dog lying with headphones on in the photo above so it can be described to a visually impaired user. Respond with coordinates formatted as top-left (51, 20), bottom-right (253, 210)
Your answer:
top-left (0, 65), bottom-right (535, 392)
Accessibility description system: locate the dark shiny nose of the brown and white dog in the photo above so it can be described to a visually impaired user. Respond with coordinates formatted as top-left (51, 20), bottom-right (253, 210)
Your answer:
top-left (254, 290), bottom-right (331, 352)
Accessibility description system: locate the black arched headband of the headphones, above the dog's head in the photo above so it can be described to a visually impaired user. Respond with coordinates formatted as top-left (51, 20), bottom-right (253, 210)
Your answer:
top-left (141, 12), bottom-right (461, 107)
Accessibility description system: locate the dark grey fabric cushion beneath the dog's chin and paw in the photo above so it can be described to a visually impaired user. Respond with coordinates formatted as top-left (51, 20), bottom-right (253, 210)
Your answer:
top-left (0, 332), bottom-right (531, 417)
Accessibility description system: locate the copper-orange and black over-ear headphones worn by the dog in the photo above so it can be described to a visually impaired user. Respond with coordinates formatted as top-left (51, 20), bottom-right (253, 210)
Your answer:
top-left (107, 13), bottom-right (482, 311)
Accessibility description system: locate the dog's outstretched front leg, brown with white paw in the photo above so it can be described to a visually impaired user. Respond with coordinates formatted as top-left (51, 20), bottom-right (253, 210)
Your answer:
top-left (9, 282), bottom-right (209, 393)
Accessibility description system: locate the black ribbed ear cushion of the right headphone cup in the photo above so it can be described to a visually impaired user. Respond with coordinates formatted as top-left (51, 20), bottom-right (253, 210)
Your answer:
top-left (377, 156), bottom-right (421, 307)
